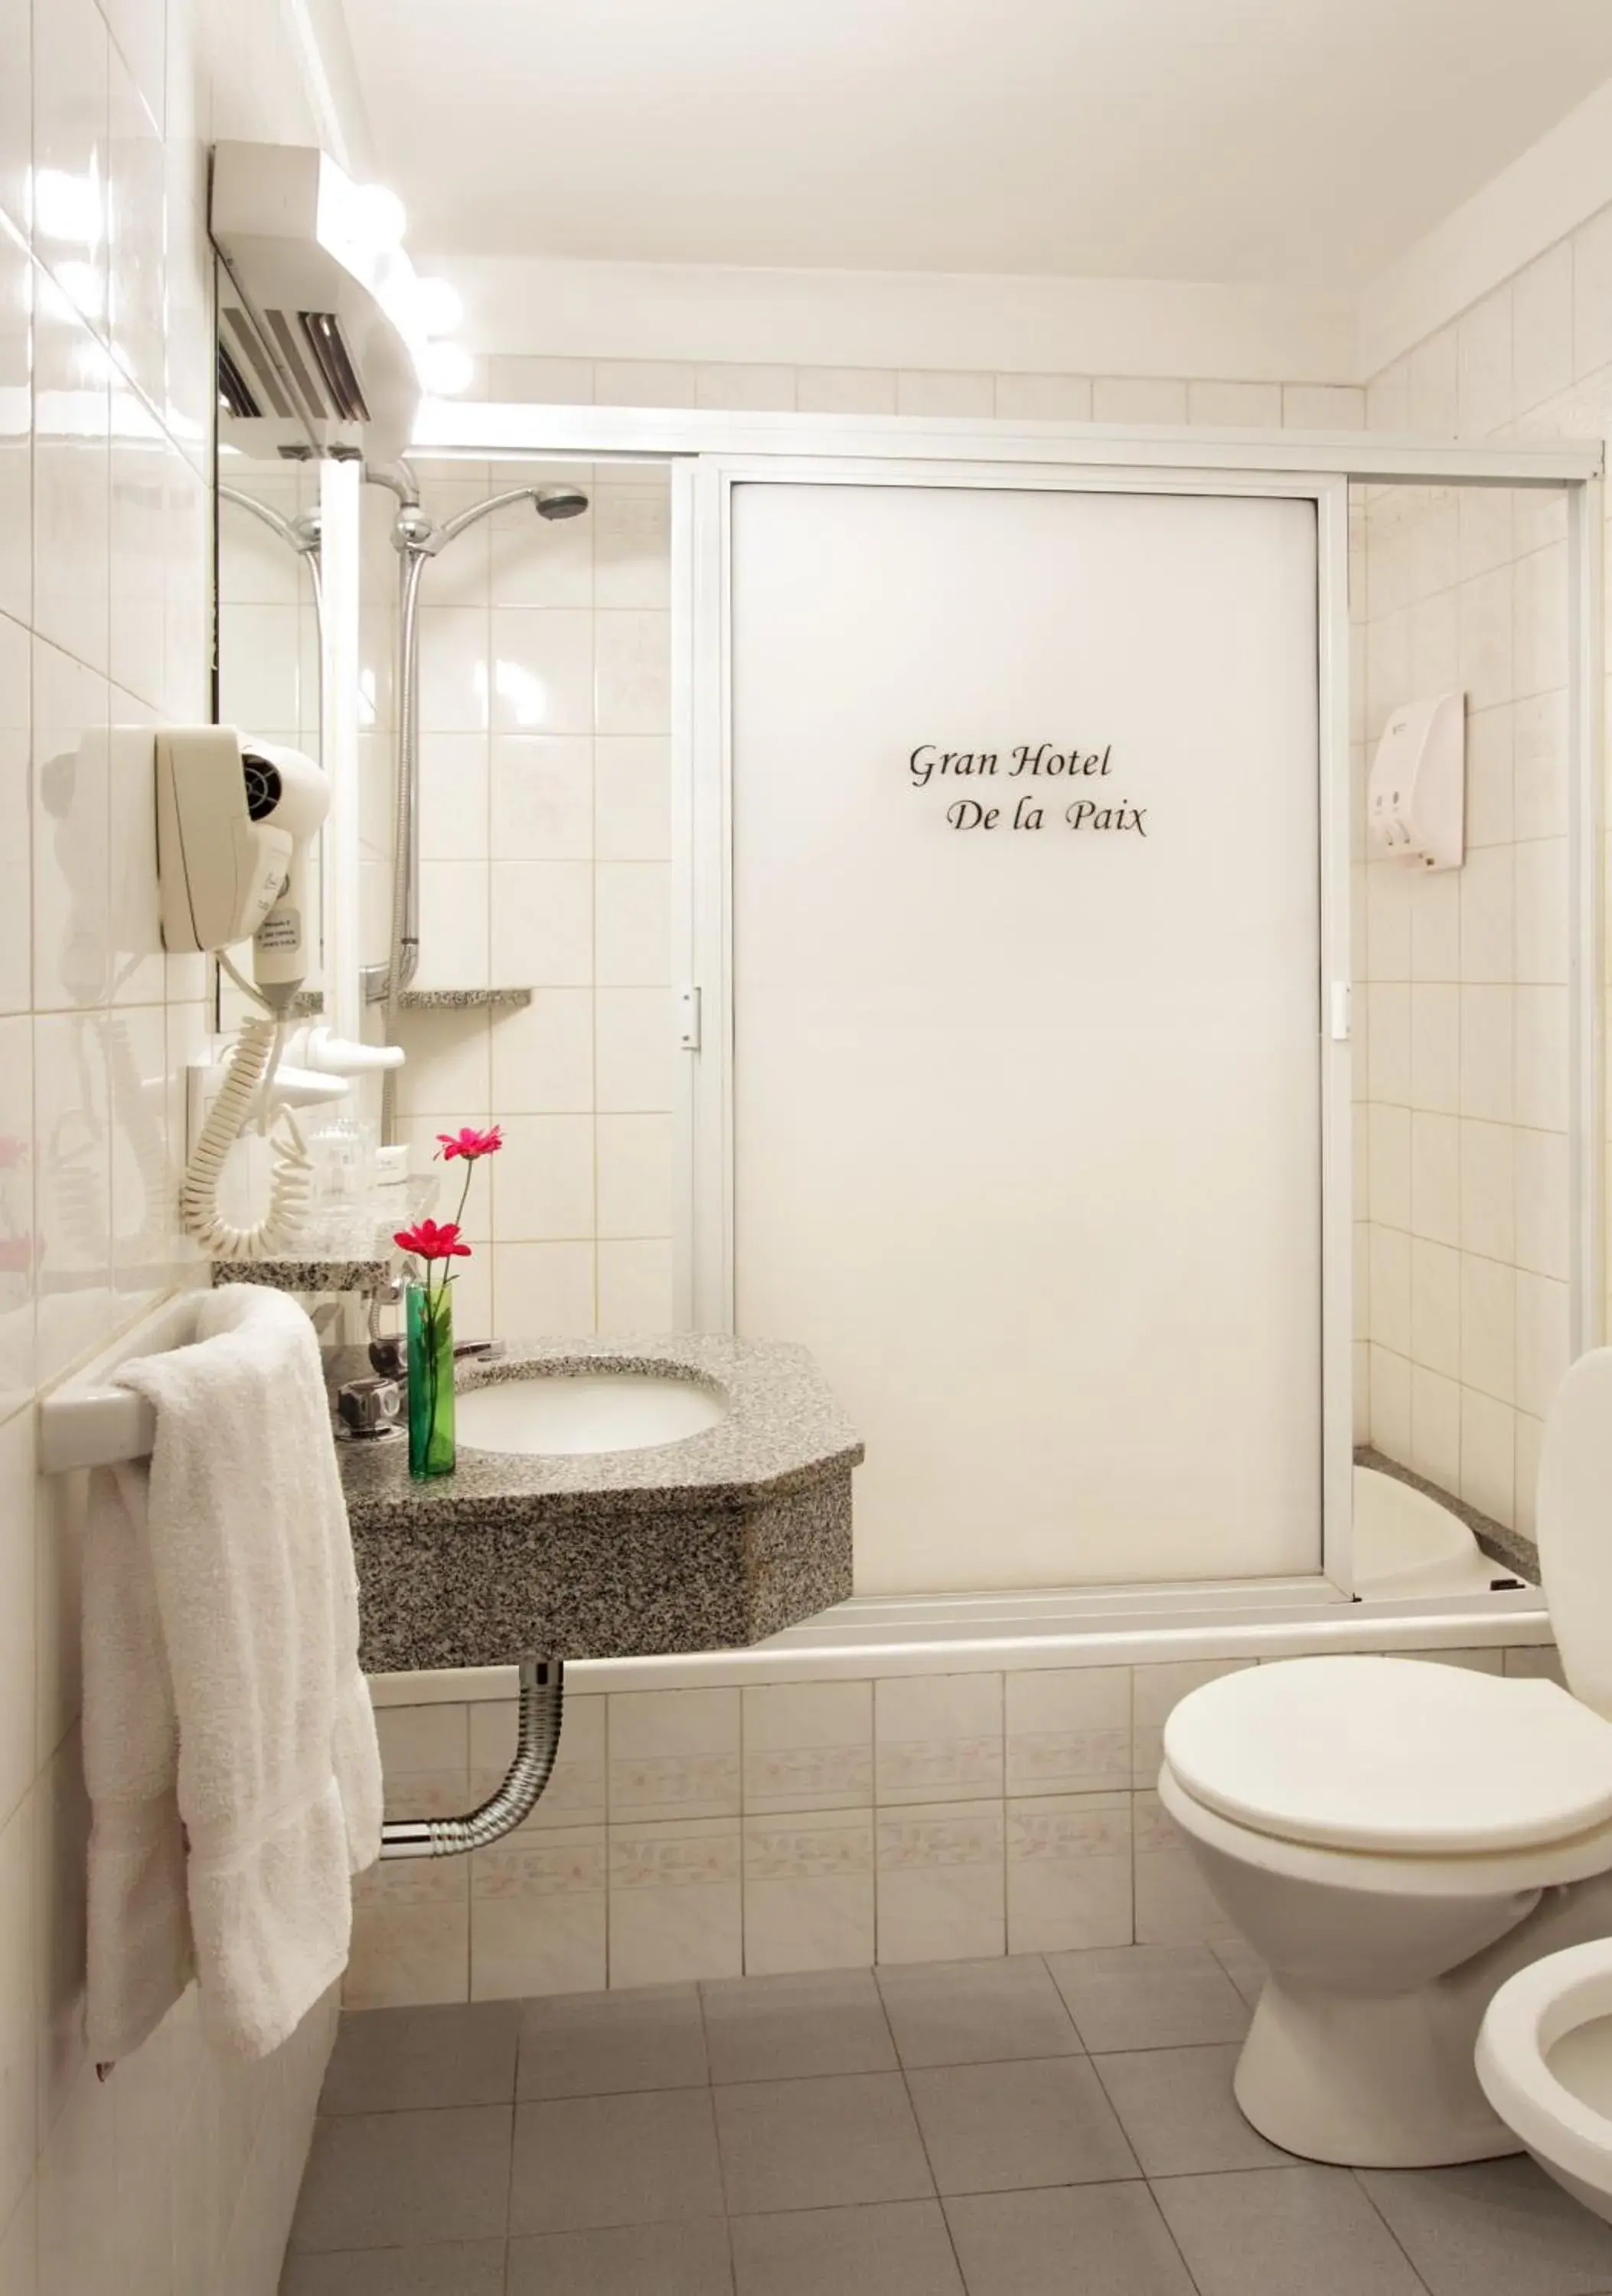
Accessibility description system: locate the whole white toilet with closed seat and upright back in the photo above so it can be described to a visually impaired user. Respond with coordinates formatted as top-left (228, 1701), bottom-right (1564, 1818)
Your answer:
top-left (1160, 1348), bottom-right (1612, 2167)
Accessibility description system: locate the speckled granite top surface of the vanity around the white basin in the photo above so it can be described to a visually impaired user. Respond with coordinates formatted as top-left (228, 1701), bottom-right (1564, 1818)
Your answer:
top-left (328, 1332), bottom-right (863, 1531)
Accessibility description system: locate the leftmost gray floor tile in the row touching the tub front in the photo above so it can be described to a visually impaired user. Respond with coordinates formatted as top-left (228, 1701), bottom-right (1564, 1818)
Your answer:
top-left (319, 2002), bottom-right (521, 2112)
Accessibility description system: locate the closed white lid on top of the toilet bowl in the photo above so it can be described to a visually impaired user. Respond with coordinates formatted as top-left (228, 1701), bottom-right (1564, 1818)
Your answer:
top-left (1164, 1658), bottom-right (1612, 1855)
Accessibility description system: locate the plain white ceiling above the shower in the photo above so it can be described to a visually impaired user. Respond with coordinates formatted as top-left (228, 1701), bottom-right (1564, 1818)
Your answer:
top-left (344, 0), bottom-right (1612, 289)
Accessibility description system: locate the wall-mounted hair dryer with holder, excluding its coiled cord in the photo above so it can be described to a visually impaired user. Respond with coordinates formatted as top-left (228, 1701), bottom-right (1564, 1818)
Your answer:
top-left (156, 726), bottom-right (331, 1013)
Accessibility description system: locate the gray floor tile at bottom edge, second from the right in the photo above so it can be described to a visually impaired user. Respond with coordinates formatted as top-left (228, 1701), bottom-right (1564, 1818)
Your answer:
top-left (1153, 2167), bottom-right (1424, 2296)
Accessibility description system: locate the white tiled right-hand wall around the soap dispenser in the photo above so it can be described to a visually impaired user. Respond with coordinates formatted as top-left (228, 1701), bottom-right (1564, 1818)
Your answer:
top-left (1355, 209), bottom-right (1612, 1529)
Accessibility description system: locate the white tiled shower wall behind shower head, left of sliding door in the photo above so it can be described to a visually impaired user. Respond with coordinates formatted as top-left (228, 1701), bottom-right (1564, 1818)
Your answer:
top-left (386, 464), bottom-right (673, 1336)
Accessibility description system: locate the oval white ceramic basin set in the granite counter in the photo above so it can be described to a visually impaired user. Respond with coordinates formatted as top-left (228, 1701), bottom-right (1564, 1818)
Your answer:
top-left (455, 1371), bottom-right (728, 1458)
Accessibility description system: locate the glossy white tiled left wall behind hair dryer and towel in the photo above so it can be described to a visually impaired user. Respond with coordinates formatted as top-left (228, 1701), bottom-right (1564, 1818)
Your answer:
top-left (0, 0), bottom-right (347, 2296)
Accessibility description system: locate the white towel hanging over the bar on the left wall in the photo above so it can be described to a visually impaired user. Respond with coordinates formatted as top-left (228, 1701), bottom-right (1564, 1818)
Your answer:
top-left (85, 1283), bottom-right (381, 2060)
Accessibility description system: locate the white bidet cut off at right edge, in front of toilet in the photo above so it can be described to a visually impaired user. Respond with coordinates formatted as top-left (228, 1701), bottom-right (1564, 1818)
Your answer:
top-left (1477, 1938), bottom-right (1612, 2220)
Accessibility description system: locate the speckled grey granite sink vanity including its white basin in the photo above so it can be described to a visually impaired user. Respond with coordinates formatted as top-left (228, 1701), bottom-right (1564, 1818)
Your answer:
top-left (333, 1332), bottom-right (861, 1674)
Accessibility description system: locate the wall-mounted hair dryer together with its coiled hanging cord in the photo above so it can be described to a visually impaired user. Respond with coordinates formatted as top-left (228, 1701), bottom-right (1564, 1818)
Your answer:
top-left (156, 726), bottom-right (331, 1261)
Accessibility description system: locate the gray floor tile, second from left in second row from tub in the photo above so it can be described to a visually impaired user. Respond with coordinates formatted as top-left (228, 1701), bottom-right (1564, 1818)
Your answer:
top-left (510, 2089), bottom-right (723, 2232)
